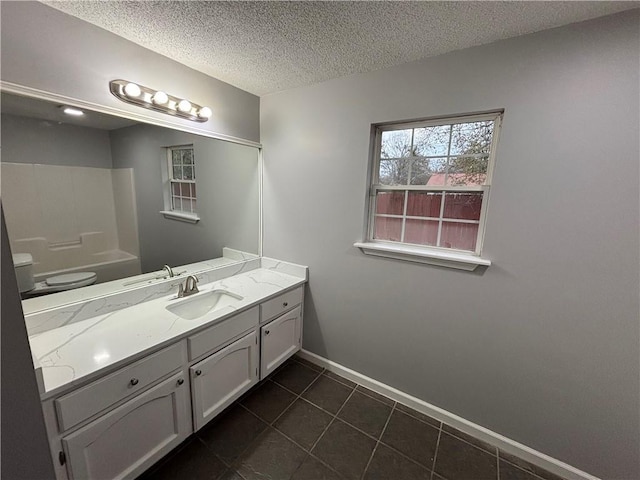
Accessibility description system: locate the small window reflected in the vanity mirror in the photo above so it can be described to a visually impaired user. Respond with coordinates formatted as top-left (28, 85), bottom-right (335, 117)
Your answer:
top-left (161, 145), bottom-right (199, 222)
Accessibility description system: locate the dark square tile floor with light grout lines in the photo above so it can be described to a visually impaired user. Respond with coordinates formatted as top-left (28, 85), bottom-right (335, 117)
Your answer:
top-left (141, 357), bottom-right (560, 480)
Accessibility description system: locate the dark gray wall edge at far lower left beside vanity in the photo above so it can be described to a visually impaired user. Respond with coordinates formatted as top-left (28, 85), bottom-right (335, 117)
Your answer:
top-left (0, 210), bottom-right (54, 480)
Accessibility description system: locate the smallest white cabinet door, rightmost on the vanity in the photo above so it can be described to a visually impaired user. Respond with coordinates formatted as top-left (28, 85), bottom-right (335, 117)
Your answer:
top-left (260, 306), bottom-right (302, 380)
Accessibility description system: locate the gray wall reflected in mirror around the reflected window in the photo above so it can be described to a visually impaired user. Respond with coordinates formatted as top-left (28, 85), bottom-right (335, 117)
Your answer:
top-left (110, 125), bottom-right (259, 272)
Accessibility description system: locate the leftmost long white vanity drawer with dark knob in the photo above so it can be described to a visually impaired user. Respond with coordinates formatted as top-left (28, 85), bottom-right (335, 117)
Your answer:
top-left (55, 342), bottom-right (185, 431)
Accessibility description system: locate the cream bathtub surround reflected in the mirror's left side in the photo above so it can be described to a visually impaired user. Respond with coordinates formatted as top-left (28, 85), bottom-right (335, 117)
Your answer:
top-left (1, 162), bottom-right (140, 282)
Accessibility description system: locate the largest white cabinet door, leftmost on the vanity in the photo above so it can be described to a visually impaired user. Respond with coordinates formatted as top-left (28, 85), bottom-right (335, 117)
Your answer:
top-left (62, 373), bottom-right (192, 480)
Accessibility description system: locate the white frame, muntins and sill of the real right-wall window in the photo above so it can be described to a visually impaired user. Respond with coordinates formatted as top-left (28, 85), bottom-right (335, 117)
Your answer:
top-left (355, 110), bottom-right (504, 270)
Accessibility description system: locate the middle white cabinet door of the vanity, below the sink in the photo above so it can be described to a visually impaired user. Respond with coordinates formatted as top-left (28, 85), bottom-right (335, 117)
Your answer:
top-left (189, 331), bottom-right (258, 430)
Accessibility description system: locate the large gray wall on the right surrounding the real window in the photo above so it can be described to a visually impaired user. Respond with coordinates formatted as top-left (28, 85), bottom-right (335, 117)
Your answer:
top-left (261, 10), bottom-right (640, 479)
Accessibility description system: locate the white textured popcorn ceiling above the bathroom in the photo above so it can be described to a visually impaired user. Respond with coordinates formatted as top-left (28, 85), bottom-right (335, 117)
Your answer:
top-left (43, 1), bottom-right (639, 95)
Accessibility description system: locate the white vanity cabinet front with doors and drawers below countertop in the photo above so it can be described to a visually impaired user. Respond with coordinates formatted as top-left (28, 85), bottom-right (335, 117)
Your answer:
top-left (43, 286), bottom-right (303, 480)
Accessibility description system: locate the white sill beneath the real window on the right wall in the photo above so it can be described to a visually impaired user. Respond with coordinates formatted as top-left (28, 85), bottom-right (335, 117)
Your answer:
top-left (353, 242), bottom-right (491, 272)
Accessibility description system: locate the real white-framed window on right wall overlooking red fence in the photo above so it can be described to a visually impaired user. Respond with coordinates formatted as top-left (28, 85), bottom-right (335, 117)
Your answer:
top-left (357, 112), bottom-right (502, 269)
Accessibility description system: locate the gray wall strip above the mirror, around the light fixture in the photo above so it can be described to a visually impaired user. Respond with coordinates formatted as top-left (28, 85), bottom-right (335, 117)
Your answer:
top-left (0, 2), bottom-right (260, 141)
